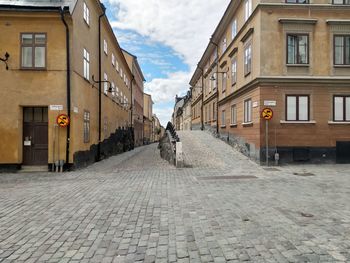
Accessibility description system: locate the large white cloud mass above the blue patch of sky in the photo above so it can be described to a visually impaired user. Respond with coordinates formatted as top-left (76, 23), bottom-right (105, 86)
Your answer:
top-left (105, 0), bottom-right (229, 70)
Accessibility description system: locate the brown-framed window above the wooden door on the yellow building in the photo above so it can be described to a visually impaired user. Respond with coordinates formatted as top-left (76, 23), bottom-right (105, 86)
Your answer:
top-left (21, 33), bottom-right (46, 69)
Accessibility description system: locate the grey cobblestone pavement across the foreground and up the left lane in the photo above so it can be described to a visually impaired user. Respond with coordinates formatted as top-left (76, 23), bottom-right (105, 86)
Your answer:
top-left (0, 135), bottom-right (350, 263)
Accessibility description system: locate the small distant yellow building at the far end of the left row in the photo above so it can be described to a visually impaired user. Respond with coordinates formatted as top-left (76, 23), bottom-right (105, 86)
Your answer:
top-left (143, 93), bottom-right (153, 144)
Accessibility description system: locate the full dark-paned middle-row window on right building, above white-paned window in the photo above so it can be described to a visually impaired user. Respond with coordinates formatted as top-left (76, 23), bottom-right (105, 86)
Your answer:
top-left (287, 34), bottom-right (309, 64)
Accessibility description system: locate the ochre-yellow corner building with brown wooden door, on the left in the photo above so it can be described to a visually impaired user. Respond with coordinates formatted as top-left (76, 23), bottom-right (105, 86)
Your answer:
top-left (0, 0), bottom-right (132, 170)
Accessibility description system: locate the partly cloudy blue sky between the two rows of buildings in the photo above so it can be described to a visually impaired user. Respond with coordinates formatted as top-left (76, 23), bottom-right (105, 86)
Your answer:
top-left (102, 0), bottom-right (230, 126)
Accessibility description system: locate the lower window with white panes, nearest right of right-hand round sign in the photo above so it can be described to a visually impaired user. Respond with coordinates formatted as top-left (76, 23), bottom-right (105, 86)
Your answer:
top-left (286, 95), bottom-right (309, 121)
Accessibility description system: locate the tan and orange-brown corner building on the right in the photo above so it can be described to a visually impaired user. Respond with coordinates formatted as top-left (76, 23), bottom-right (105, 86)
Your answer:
top-left (190, 0), bottom-right (350, 163)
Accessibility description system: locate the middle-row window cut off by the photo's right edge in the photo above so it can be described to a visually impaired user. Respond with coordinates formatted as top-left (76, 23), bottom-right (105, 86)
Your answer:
top-left (334, 35), bottom-right (350, 65)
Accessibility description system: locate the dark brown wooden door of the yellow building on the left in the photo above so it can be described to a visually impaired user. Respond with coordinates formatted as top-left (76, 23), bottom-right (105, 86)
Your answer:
top-left (23, 107), bottom-right (48, 165)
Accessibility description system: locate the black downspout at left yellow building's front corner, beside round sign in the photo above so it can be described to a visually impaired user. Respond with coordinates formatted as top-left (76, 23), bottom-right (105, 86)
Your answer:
top-left (60, 8), bottom-right (71, 170)
